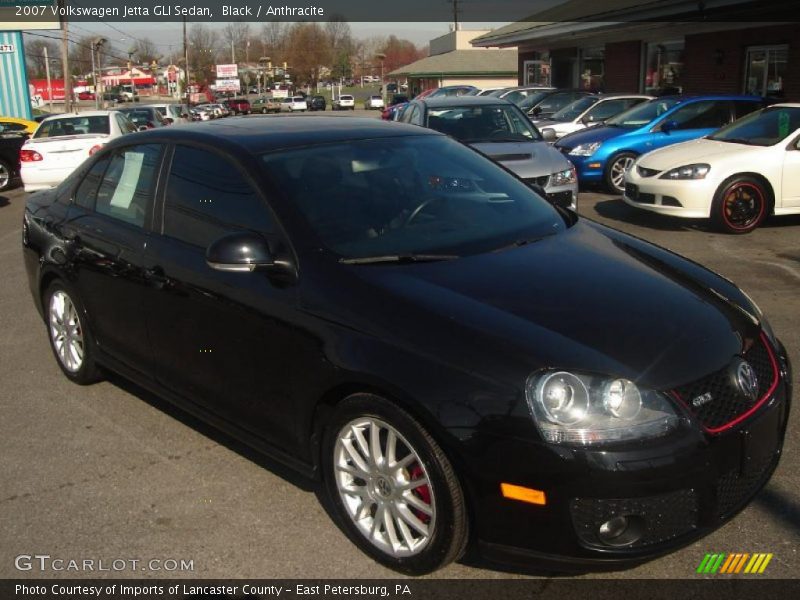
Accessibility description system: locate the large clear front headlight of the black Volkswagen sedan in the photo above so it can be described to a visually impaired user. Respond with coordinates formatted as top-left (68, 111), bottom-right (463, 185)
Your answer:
top-left (525, 371), bottom-right (679, 446)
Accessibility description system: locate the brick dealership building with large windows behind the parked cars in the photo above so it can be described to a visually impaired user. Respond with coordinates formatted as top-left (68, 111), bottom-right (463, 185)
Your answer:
top-left (471, 0), bottom-right (800, 102)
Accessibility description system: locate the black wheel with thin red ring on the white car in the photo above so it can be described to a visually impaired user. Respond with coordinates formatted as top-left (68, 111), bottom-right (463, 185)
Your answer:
top-left (711, 175), bottom-right (770, 234)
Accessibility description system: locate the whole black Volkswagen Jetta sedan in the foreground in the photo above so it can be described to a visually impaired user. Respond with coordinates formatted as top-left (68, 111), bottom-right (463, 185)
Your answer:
top-left (23, 117), bottom-right (791, 574)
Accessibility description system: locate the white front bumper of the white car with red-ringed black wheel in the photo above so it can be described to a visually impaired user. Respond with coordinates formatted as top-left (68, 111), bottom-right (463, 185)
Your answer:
top-left (622, 167), bottom-right (719, 219)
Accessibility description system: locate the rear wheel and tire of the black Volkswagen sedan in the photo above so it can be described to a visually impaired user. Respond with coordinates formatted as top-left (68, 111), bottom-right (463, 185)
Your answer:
top-left (42, 280), bottom-right (101, 385)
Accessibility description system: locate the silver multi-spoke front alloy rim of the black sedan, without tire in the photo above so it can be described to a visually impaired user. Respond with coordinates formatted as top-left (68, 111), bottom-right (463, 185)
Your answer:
top-left (333, 417), bottom-right (436, 558)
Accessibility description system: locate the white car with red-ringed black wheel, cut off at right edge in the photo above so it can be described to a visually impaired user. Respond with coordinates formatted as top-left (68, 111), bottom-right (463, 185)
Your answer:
top-left (623, 104), bottom-right (800, 233)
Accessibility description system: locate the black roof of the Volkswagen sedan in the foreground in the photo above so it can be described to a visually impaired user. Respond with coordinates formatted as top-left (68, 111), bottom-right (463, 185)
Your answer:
top-left (114, 115), bottom-right (442, 154)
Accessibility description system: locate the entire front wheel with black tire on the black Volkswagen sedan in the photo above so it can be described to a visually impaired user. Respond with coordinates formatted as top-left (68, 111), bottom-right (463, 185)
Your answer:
top-left (321, 394), bottom-right (469, 575)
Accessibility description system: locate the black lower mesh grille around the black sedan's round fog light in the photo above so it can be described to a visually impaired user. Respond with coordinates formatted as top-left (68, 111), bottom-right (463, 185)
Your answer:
top-left (570, 490), bottom-right (698, 548)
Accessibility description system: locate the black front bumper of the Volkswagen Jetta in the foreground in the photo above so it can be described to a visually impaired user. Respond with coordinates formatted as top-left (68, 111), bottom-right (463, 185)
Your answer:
top-left (460, 344), bottom-right (791, 571)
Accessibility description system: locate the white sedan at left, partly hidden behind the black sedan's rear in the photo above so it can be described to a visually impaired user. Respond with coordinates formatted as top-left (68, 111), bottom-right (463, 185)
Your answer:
top-left (19, 110), bottom-right (136, 192)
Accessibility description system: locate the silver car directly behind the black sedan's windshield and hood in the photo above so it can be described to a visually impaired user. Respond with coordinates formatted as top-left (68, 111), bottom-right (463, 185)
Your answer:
top-left (400, 96), bottom-right (578, 210)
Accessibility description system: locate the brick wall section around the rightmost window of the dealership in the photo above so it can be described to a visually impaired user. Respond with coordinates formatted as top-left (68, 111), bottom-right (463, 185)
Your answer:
top-left (683, 25), bottom-right (800, 102)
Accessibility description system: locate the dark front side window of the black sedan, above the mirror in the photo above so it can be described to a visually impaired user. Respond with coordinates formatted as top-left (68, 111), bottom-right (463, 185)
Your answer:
top-left (164, 146), bottom-right (274, 248)
